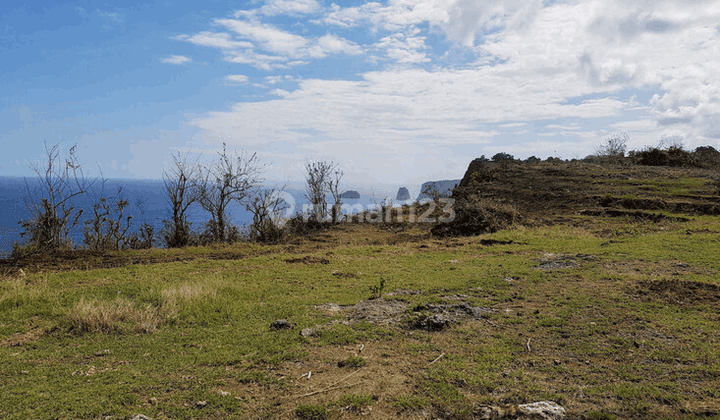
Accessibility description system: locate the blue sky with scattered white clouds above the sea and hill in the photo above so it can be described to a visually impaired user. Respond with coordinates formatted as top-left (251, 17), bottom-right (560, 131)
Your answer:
top-left (0, 0), bottom-right (720, 186)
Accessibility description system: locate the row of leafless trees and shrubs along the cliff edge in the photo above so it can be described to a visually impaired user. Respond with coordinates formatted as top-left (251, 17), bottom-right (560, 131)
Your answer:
top-left (12, 142), bottom-right (344, 256)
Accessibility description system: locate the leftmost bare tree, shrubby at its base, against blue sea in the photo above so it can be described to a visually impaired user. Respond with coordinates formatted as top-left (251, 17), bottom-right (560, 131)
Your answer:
top-left (19, 142), bottom-right (89, 250)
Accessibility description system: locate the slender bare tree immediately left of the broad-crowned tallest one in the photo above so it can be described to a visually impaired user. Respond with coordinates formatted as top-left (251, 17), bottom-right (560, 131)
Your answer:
top-left (163, 152), bottom-right (200, 248)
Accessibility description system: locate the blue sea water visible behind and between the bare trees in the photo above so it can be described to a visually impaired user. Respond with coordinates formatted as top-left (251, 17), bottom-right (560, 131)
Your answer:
top-left (0, 177), bottom-right (416, 257)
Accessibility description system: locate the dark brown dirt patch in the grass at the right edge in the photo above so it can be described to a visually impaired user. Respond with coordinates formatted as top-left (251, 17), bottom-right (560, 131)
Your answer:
top-left (631, 280), bottom-right (720, 306)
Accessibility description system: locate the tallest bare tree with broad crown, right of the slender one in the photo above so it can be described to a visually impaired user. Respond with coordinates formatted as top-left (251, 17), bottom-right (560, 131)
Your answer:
top-left (197, 143), bottom-right (263, 242)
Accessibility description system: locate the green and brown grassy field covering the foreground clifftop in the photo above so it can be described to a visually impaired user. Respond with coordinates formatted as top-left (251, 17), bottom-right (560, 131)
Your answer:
top-left (0, 160), bottom-right (720, 420)
